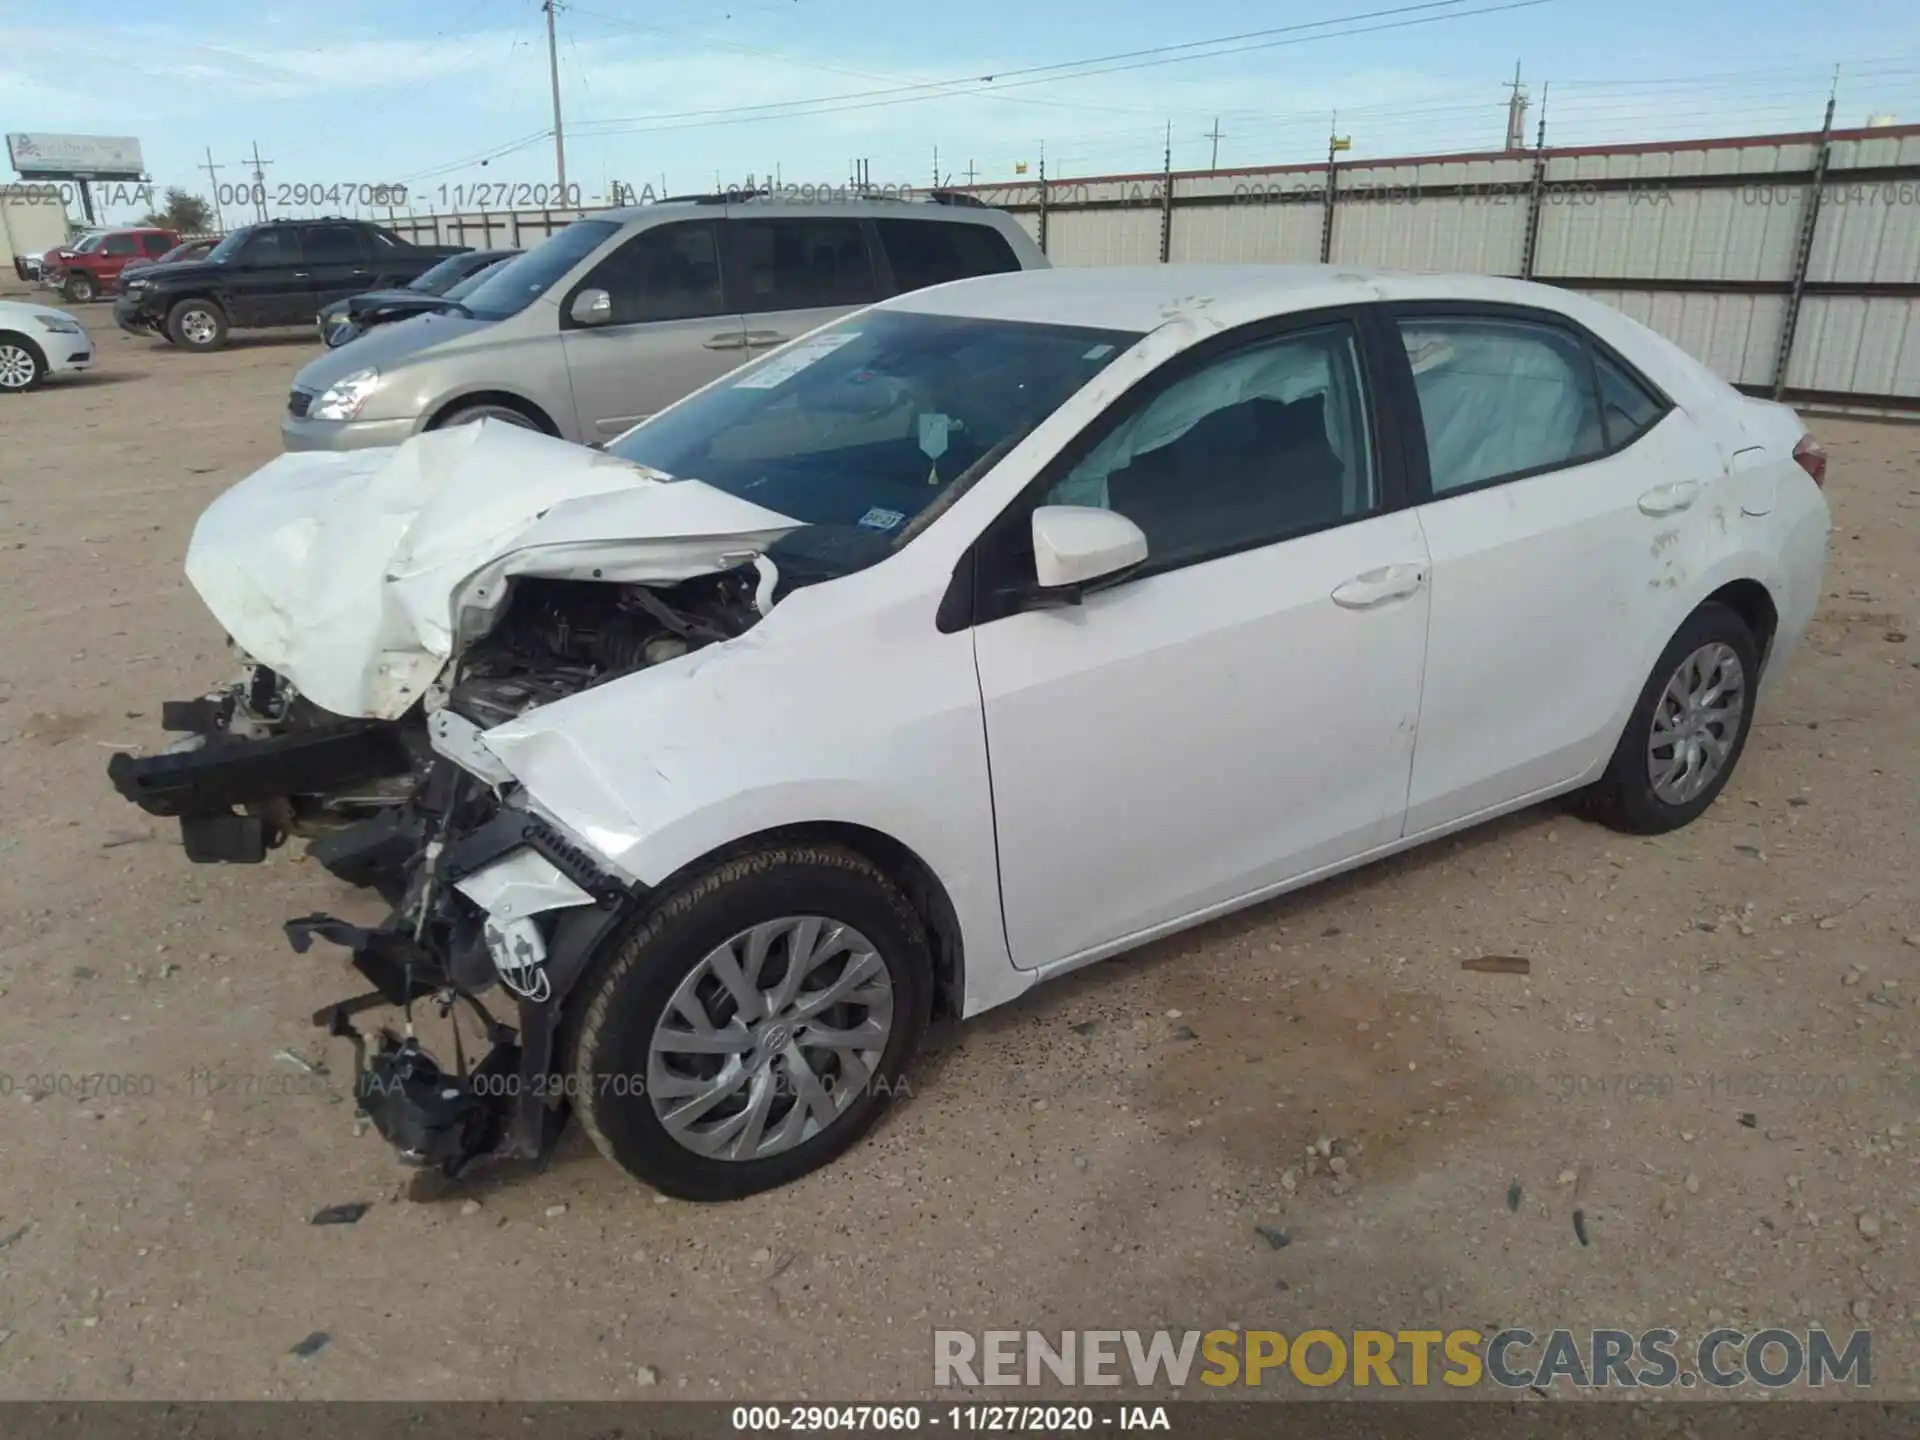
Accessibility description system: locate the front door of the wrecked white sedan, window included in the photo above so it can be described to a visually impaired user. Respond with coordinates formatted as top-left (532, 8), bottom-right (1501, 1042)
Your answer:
top-left (975, 317), bottom-right (1428, 968)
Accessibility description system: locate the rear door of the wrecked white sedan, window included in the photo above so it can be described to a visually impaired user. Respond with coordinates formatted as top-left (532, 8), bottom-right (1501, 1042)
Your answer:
top-left (1394, 303), bottom-right (1724, 833)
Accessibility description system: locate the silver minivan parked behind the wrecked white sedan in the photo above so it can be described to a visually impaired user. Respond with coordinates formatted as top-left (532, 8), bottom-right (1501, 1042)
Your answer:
top-left (280, 192), bottom-right (1046, 449)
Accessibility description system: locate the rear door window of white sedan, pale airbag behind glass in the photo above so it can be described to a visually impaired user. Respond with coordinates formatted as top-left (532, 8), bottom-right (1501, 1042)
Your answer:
top-left (1400, 317), bottom-right (1607, 497)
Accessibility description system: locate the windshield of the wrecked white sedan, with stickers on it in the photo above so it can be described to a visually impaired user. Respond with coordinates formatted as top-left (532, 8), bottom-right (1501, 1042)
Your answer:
top-left (607, 309), bottom-right (1139, 572)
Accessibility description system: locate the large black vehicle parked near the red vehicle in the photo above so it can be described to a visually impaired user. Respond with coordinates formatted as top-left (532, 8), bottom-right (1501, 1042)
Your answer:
top-left (113, 219), bottom-right (467, 349)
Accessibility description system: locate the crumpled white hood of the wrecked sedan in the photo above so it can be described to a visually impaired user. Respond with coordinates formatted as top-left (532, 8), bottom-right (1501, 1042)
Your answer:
top-left (186, 420), bottom-right (799, 720)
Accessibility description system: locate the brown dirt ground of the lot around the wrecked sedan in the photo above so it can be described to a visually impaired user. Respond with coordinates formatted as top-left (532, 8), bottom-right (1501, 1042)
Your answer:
top-left (0, 307), bottom-right (1920, 1400)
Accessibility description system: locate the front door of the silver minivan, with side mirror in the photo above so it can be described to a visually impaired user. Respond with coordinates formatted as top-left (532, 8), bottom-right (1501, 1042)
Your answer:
top-left (561, 219), bottom-right (747, 444)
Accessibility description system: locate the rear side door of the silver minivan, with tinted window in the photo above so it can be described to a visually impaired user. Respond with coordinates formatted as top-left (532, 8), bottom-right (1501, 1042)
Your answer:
top-left (726, 207), bottom-right (881, 353)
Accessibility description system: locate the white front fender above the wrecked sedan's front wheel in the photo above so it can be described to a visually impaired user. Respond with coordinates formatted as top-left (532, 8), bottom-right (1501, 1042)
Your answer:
top-left (484, 566), bottom-right (1020, 1012)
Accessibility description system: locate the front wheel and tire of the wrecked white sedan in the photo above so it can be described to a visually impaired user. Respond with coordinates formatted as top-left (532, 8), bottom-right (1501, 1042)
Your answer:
top-left (568, 845), bottom-right (933, 1200)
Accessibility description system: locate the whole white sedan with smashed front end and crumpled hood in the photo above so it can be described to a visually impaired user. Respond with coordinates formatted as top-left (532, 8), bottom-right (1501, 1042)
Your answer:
top-left (111, 265), bottom-right (1830, 1200)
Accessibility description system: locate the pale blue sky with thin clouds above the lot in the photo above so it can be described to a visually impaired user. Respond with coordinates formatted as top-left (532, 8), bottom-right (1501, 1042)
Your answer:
top-left (0, 0), bottom-right (1920, 224)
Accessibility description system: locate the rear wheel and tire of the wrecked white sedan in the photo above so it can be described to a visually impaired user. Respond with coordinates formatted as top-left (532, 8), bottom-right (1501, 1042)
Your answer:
top-left (1582, 603), bottom-right (1761, 835)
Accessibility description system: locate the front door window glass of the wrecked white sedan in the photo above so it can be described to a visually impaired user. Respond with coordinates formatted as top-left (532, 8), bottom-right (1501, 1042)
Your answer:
top-left (1044, 323), bottom-right (1379, 570)
